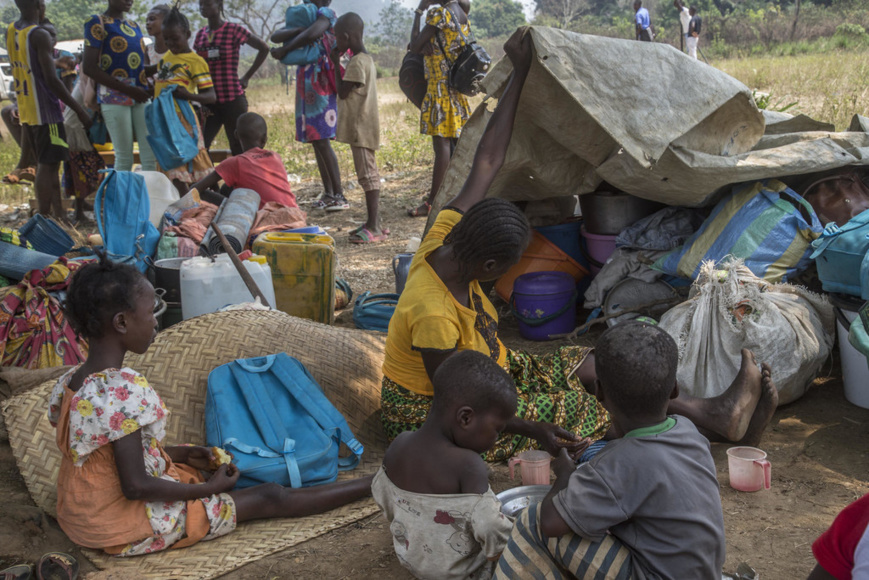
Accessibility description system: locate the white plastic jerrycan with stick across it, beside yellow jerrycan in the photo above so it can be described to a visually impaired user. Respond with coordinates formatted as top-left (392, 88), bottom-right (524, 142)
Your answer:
top-left (181, 254), bottom-right (275, 320)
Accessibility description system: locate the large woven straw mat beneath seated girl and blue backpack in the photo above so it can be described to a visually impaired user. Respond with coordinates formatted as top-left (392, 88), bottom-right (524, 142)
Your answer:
top-left (3, 311), bottom-right (386, 578)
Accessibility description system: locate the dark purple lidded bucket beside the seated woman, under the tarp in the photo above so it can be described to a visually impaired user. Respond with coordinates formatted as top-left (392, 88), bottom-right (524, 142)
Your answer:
top-left (510, 272), bottom-right (577, 340)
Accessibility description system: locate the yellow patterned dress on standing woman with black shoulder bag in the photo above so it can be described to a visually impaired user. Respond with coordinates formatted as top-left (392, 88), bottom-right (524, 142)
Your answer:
top-left (420, 6), bottom-right (471, 139)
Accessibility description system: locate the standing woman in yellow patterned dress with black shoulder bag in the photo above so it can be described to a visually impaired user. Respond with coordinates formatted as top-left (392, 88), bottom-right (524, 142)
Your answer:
top-left (407, 0), bottom-right (471, 217)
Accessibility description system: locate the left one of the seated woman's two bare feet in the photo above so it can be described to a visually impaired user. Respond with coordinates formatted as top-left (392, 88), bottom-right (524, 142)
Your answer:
top-left (705, 348), bottom-right (761, 441)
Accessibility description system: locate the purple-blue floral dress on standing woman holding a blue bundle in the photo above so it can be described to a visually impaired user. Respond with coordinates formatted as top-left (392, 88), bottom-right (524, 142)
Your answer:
top-left (296, 8), bottom-right (338, 143)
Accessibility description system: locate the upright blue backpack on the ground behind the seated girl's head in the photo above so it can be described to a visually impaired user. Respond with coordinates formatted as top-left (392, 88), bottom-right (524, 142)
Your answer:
top-left (94, 169), bottom-right (160, 272)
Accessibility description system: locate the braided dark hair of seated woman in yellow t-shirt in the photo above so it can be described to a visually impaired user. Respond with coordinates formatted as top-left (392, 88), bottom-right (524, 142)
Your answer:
top-left (444, 198), bottom-right (531, 268)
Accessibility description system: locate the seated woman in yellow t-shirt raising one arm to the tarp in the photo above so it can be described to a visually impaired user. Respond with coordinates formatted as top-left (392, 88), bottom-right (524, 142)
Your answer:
top-left (381, 30), bottom-right (777, 461)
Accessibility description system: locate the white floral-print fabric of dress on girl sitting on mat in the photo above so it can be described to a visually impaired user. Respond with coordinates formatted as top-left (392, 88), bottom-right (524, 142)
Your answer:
top-left (48, 368), bottom-right (236, 556)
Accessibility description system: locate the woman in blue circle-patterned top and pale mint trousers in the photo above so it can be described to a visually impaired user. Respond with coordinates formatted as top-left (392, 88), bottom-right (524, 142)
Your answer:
top-left (82, 0), bottom-right (157, 171)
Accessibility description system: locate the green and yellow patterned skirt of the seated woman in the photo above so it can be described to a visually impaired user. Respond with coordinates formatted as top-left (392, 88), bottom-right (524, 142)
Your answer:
top-left (380, 346), bottom-right (610, 461)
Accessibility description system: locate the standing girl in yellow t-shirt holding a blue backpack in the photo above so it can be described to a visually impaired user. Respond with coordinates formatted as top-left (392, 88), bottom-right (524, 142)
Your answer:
top-left (154, 7), bottom-right (217, 195)
